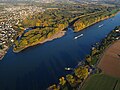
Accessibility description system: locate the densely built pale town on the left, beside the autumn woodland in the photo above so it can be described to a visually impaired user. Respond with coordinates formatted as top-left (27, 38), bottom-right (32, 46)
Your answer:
top-left (0, 3), bottom-right (45, 60)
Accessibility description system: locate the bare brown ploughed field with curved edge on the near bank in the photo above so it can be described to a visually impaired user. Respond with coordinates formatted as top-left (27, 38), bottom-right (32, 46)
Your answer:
top-left (98, 40), bottom-right (120, 78)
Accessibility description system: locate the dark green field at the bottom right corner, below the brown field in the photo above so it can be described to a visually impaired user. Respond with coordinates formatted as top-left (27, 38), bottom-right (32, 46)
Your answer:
top-left (82, 74), bottom-right (120, 90)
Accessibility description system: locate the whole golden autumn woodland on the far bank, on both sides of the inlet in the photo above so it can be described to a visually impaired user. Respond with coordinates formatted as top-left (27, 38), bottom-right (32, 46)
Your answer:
top-left (13, 5), bottom-right (119, 53)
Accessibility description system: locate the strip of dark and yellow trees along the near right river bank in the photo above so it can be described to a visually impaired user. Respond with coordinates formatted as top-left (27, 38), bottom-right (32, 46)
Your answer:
top-left (48, 26), bottom-right (120, 90)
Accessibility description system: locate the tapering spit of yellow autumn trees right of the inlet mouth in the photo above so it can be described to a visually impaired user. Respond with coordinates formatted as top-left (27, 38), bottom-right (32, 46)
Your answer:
top-left (72, 10), bottom-right (119, 32)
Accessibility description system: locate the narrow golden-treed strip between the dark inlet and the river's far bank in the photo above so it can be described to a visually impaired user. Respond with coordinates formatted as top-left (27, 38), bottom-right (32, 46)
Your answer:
top-left (73, 11), bottom-right (118, 32)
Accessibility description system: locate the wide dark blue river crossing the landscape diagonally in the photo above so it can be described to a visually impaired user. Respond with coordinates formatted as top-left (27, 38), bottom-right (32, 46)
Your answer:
top-left (0, 13), bottom-right (120, 90)
